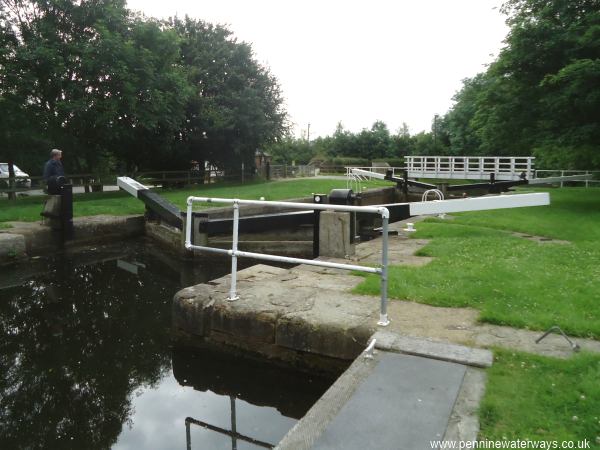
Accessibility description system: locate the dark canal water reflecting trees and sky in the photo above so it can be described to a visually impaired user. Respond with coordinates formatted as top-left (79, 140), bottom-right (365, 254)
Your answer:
top-left (0, 240), bottom-right (333, 450)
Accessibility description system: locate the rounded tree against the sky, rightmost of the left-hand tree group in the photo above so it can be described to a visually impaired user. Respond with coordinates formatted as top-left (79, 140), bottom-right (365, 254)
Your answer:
top-left (171, 17), bottom-right (288, 174)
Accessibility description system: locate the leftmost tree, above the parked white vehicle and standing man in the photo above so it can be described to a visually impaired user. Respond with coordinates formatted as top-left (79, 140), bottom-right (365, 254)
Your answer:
top-left (0, 0), bottom-right (136, 170)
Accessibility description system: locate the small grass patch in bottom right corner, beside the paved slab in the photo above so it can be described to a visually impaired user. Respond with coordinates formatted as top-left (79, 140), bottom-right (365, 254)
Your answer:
top-left (479, 349), bottom-right (600, 442)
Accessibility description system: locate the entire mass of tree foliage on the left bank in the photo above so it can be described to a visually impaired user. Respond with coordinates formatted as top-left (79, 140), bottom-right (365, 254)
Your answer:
top-left (0, 0), bottom-right (286, 175)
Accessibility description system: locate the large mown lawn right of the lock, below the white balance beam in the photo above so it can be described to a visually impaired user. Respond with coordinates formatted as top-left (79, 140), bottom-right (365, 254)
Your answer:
top-left (357, 188), bottom-right (600, 339)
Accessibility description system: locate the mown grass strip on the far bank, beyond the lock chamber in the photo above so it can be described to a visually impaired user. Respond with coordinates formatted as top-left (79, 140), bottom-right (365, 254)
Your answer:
top-left (0, 178), bottom-right (389, 226)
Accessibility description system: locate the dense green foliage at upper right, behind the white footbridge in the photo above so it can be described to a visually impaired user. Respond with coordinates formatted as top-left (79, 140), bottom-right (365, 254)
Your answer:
top-left (446, 0), bottom-right (600, 169)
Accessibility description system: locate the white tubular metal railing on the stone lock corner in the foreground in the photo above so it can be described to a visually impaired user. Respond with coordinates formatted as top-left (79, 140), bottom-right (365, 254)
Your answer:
top-left (185, 196), bottom-right (390, 326)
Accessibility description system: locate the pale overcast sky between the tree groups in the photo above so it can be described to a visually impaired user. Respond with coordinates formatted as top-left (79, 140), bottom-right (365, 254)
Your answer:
top-left (128, 0), bottom-right (508, 139)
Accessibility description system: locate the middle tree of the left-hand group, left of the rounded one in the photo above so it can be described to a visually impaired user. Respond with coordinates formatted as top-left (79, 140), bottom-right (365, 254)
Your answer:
top-left (102, 18), bottom-right (193, 171)
